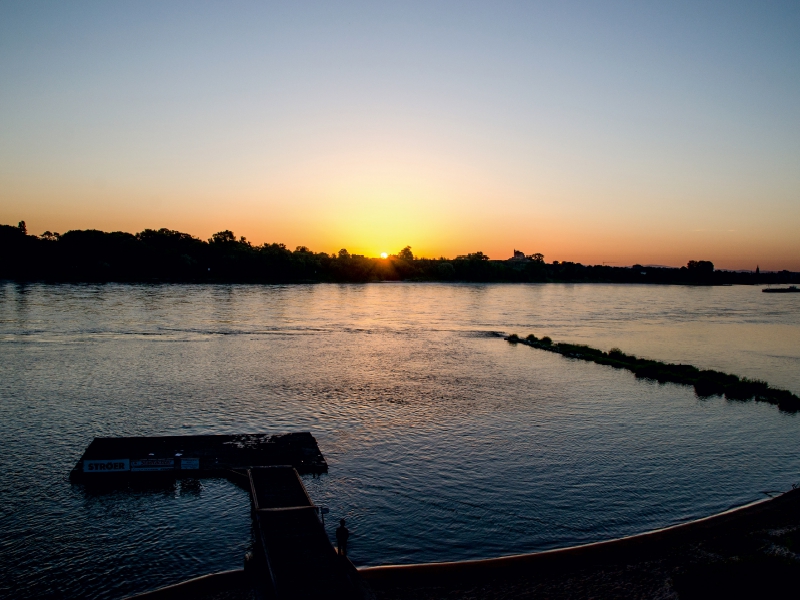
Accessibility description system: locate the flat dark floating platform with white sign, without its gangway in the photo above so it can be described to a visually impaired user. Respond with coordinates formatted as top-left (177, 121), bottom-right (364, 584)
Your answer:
top-left (70, 432), bottom-right (328, 484)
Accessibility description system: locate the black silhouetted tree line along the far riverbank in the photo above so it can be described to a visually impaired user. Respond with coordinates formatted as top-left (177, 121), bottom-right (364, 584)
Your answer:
top-left (0, 221), bottom-right (800, 285)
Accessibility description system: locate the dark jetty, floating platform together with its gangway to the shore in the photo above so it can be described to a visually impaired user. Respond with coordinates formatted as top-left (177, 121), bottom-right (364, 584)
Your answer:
top-left (70, 432), bottom-right (372, 600)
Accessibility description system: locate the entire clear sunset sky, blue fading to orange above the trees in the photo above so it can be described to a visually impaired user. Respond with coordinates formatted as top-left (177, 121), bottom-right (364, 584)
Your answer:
top-left (0, 0), bottom-right (800, 271)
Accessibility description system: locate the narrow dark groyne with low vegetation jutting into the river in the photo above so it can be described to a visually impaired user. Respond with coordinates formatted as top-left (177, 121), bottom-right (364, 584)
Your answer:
top-left (504, 333), bottom-right (800, 412)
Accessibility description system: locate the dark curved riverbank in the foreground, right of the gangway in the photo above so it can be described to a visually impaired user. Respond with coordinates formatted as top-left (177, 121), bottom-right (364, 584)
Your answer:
top-left (361, 489), bottom-right (800, 600)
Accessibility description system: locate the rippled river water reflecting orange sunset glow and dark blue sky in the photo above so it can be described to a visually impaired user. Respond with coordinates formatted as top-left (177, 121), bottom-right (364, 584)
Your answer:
top-left (0, 284), bottom-right (800, 598)
